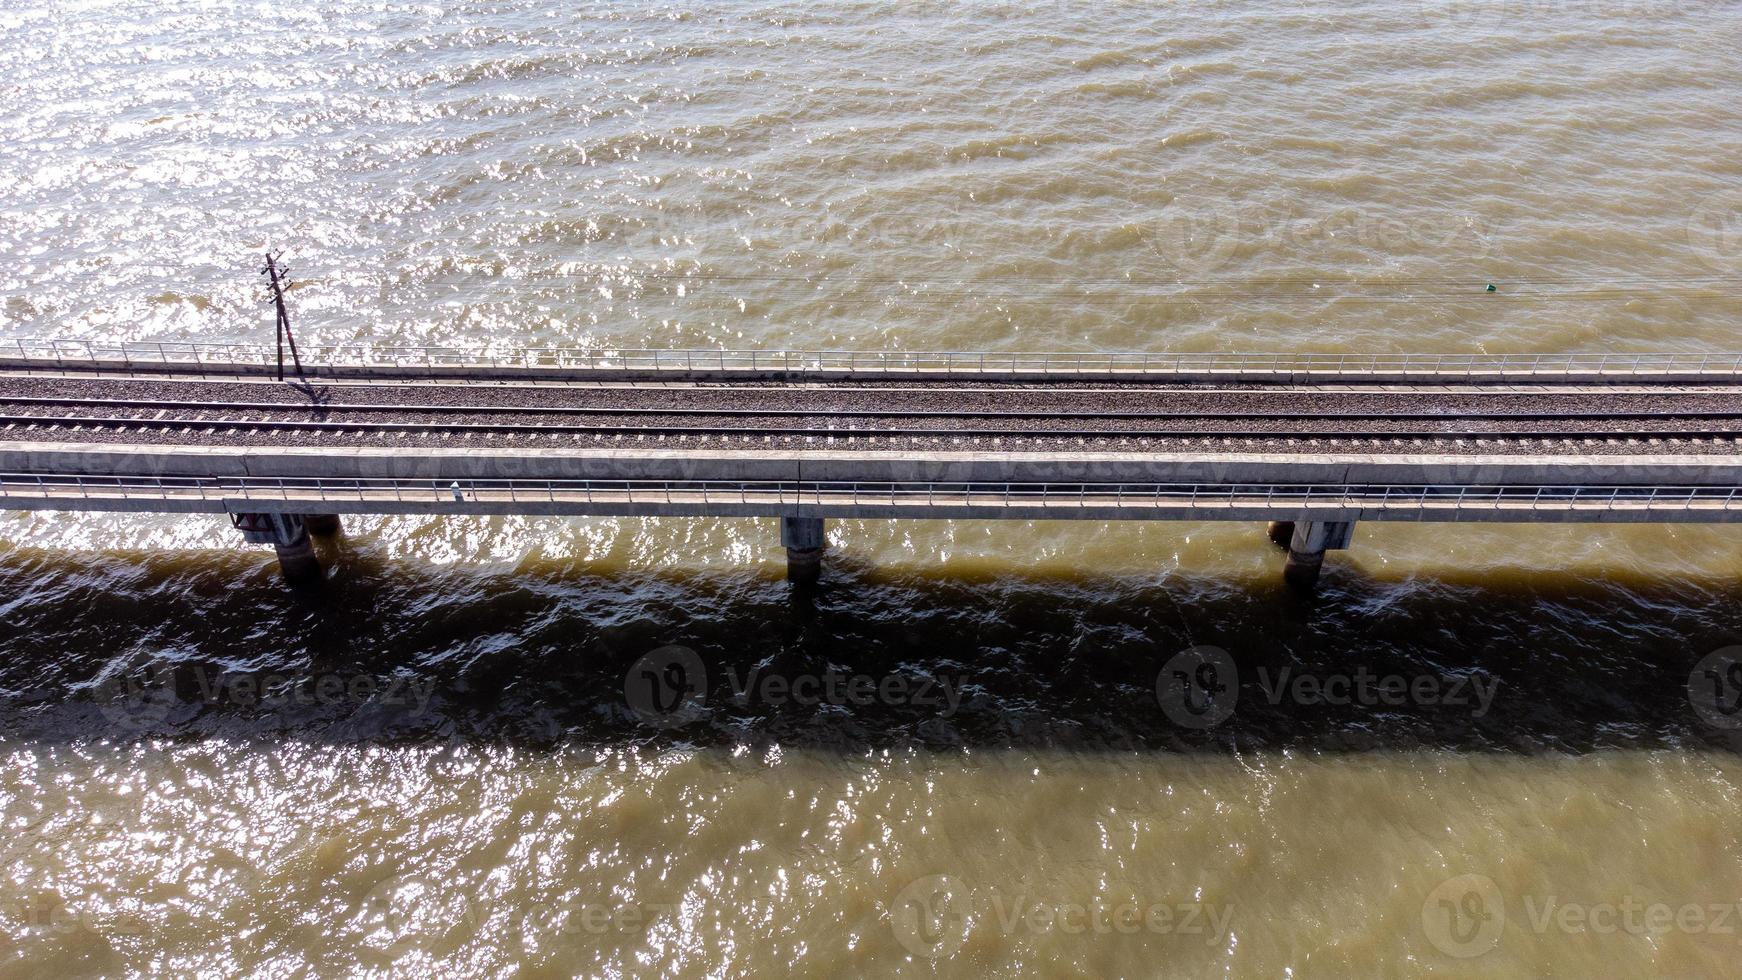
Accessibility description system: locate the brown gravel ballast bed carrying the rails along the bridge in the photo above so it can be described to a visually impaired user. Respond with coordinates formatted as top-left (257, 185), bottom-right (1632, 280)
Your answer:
top-left (0, 376), bottom-right (1742, 454)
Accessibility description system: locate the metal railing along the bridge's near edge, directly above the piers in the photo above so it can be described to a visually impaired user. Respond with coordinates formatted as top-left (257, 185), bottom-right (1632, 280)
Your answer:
top-left (0, 473), bottom-right (1742, 517)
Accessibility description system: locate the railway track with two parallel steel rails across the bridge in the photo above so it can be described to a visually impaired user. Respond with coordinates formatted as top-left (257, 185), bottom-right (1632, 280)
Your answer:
top-left (10, 390), bottom-right (1742, 446)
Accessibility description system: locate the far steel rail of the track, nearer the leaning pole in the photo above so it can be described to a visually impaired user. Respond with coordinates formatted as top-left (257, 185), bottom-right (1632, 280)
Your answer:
top-left (0, 395), bottom-right (1742, 421)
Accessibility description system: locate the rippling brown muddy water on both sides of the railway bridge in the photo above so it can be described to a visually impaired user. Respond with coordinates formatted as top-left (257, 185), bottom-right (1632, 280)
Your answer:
top-left (0, 0), bottom-right (1742, 977)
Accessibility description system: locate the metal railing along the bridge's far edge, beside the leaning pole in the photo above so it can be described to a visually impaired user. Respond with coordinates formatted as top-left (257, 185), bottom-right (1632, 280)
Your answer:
top-left (10, 339), bottom-right (1742, 378)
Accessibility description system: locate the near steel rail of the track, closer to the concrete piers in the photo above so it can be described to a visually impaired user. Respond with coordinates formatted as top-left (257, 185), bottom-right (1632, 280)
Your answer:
top-left (0, 416), bottom-right (1742, 442)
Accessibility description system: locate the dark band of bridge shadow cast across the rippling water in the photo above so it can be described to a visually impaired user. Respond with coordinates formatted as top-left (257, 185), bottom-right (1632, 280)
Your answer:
top-left (0, 536), bottom-right (1742, 754)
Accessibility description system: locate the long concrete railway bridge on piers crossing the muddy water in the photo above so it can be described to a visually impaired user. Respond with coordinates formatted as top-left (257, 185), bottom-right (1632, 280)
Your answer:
top-left (0, 341), bottom-right (1742, 590)
